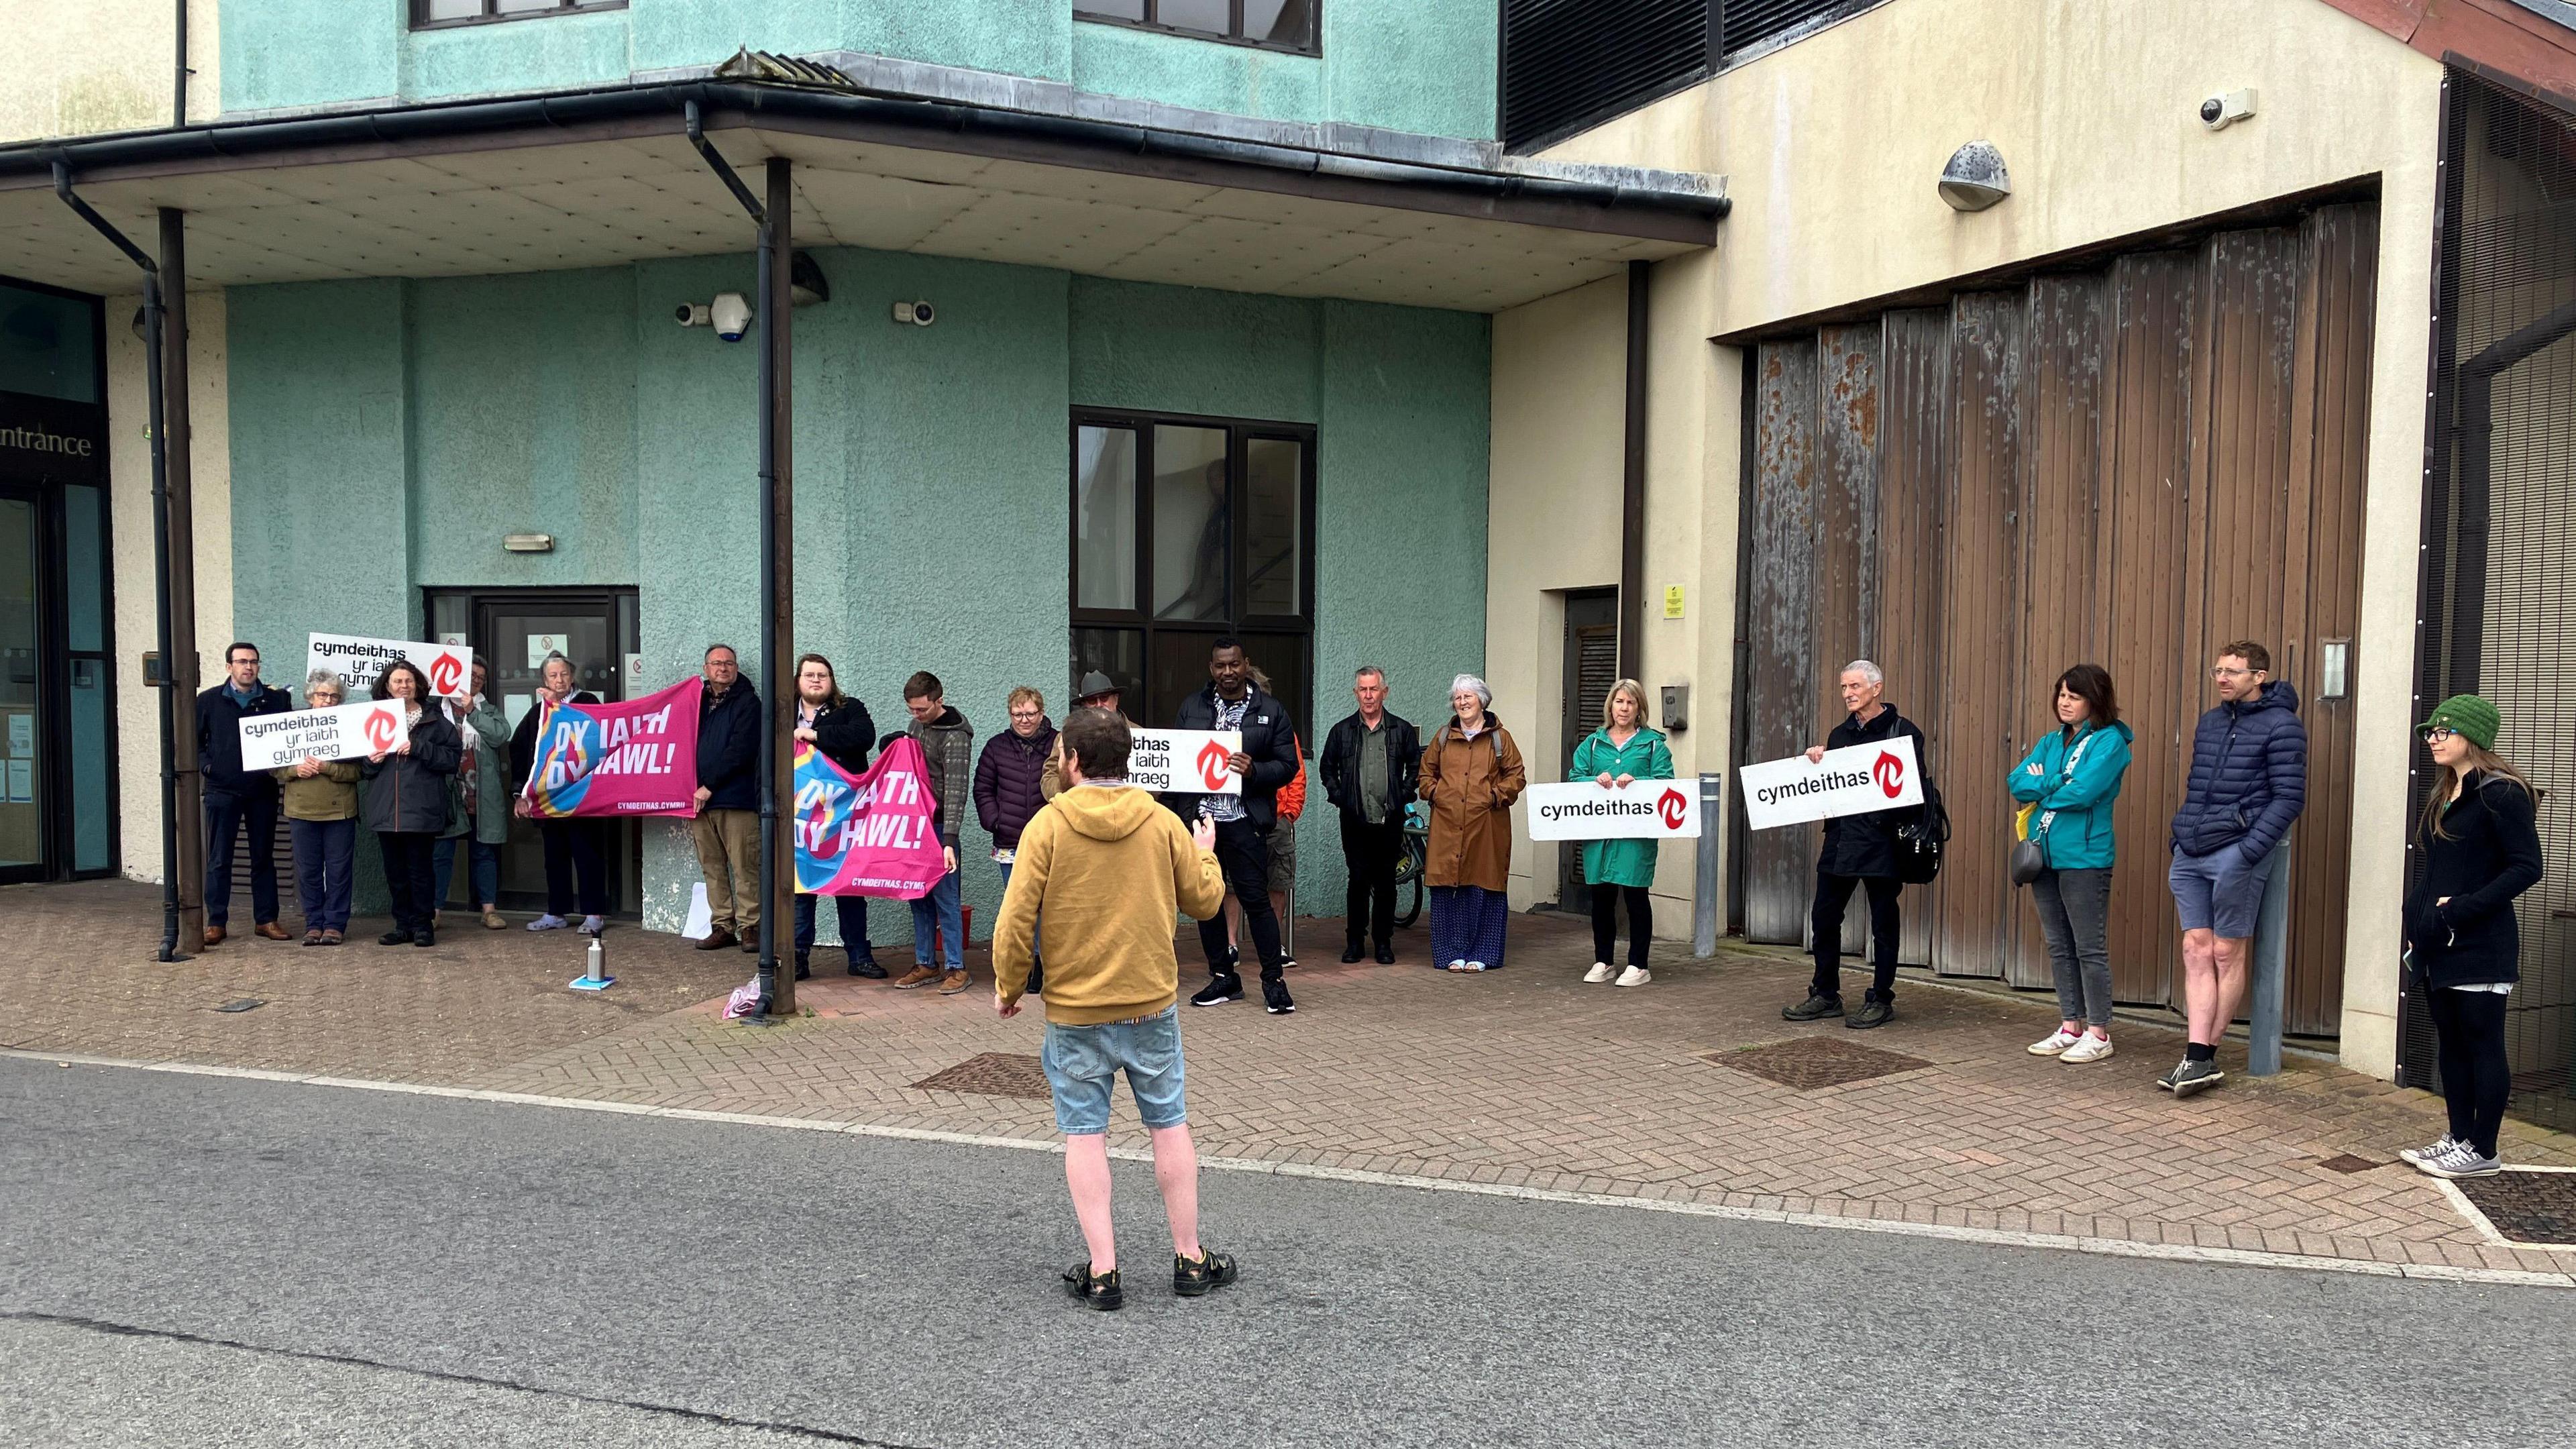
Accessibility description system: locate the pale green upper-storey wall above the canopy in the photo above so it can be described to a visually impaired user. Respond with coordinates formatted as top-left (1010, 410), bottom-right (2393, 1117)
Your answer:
top-left (219, 0), bottom-right (1497, 140)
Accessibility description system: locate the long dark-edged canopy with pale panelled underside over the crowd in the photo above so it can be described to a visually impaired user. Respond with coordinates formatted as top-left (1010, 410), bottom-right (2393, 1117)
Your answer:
top-left (0, 88), bottom-right (1723, 312)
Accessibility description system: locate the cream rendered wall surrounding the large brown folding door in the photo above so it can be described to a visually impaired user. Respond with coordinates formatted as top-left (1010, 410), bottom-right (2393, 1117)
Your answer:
top-left (1491, 0), bottom-right (2442, 1075)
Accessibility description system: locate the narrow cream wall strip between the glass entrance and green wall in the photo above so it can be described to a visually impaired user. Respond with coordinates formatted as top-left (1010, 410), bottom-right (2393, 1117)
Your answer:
top-left (105, 291), bottom-right (234, 881)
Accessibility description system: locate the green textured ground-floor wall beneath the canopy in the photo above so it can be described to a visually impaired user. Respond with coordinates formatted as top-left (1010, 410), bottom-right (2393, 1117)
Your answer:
top-left (229, 250), bottom-right (1489, 928)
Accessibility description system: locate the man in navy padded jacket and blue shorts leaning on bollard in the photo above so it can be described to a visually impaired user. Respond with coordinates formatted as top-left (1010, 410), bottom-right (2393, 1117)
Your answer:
top-left (2156, 639), bottom-right (2308, 1095)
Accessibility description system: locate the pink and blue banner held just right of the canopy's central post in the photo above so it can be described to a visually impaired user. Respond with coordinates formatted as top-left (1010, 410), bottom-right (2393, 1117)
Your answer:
top-left (796, 735), bottom-right (948, 900)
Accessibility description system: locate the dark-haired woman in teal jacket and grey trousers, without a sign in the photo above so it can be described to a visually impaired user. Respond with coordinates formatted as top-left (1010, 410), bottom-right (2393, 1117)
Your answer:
top-left (2012, 665), bottom-right (2133, 1062)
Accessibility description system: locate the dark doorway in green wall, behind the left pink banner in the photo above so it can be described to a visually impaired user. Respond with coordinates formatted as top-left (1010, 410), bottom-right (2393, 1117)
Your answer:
top-left (427, 588), bottom-right (644, 915)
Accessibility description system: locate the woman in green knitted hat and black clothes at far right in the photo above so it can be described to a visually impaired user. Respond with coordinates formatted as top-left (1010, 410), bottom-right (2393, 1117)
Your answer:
top-left (2398, 694), bottom-right (2542, 1178)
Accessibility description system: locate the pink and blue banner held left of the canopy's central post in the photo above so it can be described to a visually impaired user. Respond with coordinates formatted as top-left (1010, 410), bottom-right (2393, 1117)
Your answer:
top-left (521, 678), bottom-right (703, 820)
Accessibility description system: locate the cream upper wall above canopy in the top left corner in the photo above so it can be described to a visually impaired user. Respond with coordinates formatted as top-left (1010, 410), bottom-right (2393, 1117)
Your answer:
top-left (0, 0), bottom-right (221, 142)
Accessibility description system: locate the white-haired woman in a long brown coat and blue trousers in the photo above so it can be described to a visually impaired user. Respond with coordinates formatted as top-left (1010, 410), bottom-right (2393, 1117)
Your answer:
top-left (1422, 673), bottom-right (1527, 972)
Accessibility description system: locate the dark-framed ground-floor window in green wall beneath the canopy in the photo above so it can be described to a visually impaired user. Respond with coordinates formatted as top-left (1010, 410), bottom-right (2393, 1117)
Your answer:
top-left (1069, 410), bottom-right (1313, 750)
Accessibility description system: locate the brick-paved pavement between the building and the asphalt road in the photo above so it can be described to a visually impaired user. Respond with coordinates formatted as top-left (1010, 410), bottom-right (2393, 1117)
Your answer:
top-left (0, 881), bottom-right (2576, 1274)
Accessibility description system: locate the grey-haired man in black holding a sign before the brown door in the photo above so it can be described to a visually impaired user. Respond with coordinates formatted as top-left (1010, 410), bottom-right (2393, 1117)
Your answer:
top-left (1780, 660), bottom-right (1932, 1031)
